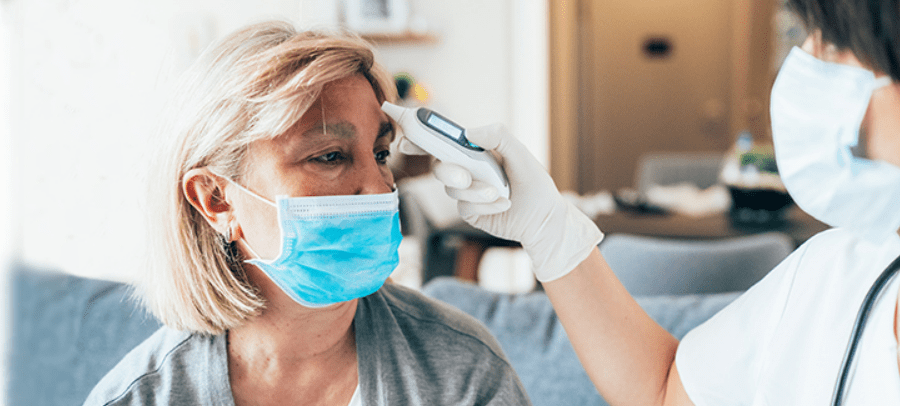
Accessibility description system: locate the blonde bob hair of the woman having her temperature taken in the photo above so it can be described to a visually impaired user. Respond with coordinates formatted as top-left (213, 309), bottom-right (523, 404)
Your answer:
top-left (136, 21), bottom-right (396, 334)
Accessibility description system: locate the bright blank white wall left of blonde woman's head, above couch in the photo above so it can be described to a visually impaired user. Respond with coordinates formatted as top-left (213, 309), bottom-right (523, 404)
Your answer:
top-left (7, 0), bottom-right (308, 280)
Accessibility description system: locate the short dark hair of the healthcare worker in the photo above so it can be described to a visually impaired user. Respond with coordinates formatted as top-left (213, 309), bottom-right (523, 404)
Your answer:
top-left (788, 0), bottom-right (900, 81)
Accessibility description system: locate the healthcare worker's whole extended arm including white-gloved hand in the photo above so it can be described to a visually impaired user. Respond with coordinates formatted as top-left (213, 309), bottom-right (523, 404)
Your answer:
top-left (400, 126), bottom-right (691, 405)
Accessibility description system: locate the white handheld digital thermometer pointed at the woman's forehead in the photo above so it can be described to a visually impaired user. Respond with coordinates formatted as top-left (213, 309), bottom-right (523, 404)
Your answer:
top-left (381, 102), bottom-right (509, 199)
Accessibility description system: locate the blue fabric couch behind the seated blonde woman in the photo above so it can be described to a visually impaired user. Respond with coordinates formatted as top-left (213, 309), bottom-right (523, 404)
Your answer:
top-left (7, 266), bottom-right (736, 406)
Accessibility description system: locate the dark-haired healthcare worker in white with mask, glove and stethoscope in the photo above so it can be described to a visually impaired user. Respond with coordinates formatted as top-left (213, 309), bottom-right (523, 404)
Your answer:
top-left (420, 0), bottom-right (900, 405)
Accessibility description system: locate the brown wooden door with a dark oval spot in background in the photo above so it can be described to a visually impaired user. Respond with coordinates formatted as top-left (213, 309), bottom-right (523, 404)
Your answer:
top-left (575, 0), bottom-right (734, 193)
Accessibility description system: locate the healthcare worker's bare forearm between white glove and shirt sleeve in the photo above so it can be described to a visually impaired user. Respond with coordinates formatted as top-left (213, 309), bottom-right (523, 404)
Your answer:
top-left (543, 248), bottom-right (693, 405)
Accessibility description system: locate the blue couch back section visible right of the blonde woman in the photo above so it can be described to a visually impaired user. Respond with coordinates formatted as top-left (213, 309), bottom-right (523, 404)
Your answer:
top-left (423, 278), bottom-right (739, 406)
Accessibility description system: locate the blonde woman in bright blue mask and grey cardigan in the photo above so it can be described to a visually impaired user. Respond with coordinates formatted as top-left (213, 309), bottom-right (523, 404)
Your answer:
top-left (85, 22), bottom-right (528, 405)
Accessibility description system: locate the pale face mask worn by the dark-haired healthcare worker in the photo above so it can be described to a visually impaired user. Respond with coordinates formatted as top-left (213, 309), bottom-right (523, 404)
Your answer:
top-left (771, 47), bottom-right (900, 238)
